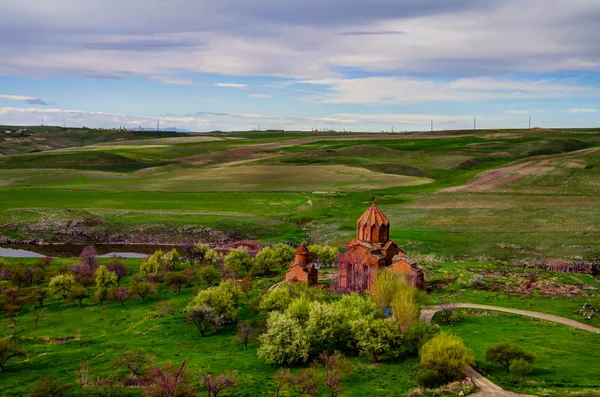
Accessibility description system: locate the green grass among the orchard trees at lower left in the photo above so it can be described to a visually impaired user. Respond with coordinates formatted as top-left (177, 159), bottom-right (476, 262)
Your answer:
top-left (0, 259), bottom-right (417, 397)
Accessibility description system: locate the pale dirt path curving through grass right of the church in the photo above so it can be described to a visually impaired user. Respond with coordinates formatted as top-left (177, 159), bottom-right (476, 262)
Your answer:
top-left (421, 303), bottom-right (600, 397)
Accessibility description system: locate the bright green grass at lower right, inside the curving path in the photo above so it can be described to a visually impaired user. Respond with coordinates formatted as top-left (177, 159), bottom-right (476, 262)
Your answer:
top-left (442, 312), bottom-right (600, 396)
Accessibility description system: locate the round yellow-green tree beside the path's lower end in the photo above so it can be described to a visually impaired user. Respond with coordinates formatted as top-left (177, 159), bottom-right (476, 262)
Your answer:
top-left (419, 332), bottom-right (473, 385)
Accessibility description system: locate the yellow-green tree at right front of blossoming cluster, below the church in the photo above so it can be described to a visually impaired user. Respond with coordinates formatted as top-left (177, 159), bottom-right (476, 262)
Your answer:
top-left (351, 319), bottom-right (402, 362)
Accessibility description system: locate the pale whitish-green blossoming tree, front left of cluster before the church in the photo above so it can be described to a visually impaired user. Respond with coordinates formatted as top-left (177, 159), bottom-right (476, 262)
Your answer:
top-left (258, 312), bottom-right (309, 365)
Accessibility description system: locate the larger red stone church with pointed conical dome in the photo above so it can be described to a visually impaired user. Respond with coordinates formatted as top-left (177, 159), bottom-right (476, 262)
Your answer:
top-left (338, 203), bottom-right (425, 291)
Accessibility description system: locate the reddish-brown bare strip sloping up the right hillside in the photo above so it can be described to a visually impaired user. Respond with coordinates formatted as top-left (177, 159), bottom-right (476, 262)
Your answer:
top-left (440, 147), bottom-right (600, 193)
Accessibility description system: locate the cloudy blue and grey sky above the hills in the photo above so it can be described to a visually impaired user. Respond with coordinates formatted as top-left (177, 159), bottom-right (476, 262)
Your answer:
top-left (0, 0), bottom-right (600, 131)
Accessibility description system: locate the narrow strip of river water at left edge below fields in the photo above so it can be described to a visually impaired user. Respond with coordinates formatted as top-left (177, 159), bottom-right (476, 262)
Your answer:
top-left (0, 244), bottom-right (172, 258)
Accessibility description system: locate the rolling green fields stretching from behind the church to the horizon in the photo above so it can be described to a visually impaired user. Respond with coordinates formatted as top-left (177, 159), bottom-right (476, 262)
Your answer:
top-left (0, 127), bottom-right (600, 260)
